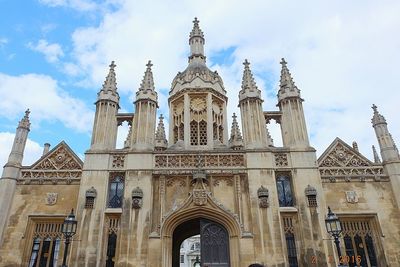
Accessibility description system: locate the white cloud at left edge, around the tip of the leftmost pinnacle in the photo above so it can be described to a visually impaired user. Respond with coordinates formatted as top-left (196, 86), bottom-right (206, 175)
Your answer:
top-left (0, 73), bottom-right (93, 133)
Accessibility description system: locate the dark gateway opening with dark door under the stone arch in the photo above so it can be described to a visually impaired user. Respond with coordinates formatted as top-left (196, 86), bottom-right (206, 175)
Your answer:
top-left (172, 218), bottom-right (229, 267)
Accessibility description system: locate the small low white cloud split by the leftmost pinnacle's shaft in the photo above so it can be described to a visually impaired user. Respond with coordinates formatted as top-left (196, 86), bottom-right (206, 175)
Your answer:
top-left (0, 132), bottom-right (43, 167)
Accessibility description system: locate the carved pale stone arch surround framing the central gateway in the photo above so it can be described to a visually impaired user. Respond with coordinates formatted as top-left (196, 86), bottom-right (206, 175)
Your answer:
top-left (160, 192), bottom-right (242, 267)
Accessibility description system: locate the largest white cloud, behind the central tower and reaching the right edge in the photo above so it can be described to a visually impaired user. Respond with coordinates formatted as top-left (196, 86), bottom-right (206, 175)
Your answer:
top-left (32, 0), bottom-right (400, 159)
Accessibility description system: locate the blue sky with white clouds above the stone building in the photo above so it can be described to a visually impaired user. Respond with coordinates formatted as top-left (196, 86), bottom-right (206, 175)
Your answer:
top-left (0, 0), bottom-right (400, 166)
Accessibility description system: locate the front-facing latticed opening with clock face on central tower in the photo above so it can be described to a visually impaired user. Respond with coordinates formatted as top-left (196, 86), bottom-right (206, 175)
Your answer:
top-left (190, 96), bottom-right (207, 146)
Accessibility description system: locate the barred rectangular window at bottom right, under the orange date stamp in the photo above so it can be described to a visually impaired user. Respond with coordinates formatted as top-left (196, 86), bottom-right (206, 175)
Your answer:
top-left (340, 218), bottom-right (378, 267)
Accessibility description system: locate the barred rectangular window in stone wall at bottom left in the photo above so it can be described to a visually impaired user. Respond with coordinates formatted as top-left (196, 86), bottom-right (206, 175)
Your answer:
top-left (28, 218), bottom-right (62, 267)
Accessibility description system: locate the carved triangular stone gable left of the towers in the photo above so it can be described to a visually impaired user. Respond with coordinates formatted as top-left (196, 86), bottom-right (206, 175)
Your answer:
top-left (30, 141), bottom-right (83, 171)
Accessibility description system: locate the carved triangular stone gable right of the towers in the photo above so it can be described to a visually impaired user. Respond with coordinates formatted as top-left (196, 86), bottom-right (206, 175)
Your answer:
top-left (318, 138), bottom-right (374, 167)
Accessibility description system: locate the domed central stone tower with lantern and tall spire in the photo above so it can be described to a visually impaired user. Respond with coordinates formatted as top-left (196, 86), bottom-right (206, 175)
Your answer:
top-left (168, 18), bottom-right (228, 150)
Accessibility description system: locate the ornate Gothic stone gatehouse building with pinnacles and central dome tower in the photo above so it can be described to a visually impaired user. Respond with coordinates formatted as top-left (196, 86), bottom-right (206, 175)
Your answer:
top-left (0, 19), bottom-right (400, 267)
